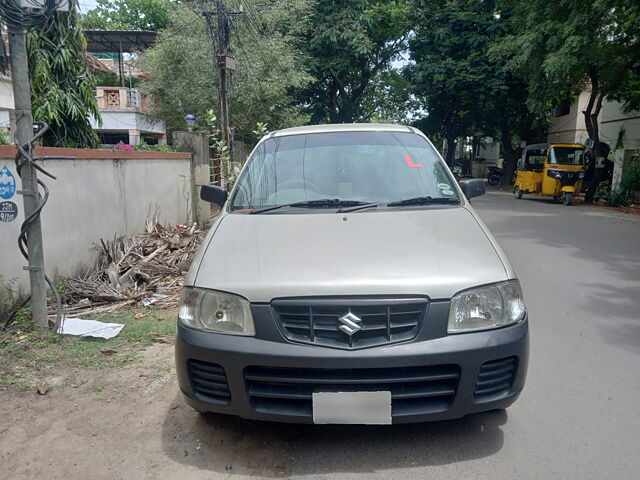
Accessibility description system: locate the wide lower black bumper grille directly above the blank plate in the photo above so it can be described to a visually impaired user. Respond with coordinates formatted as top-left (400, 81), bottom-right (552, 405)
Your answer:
top-left (244, 365), bottom-right (460, 418)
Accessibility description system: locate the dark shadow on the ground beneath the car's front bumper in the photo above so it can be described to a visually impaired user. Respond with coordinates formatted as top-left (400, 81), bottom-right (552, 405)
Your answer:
top-left (162, 395), bottom-right (507, 477)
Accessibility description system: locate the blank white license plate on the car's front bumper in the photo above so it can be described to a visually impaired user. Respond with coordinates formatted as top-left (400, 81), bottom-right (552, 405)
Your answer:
top-left (312, 392), bottom-right (391, 425)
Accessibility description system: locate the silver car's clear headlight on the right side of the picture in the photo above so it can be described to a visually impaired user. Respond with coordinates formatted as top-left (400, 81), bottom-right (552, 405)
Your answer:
top-left (447, 280), bottom-right (525, 333)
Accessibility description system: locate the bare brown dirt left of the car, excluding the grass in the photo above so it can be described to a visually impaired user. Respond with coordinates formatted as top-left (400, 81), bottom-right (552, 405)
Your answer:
top-left (0, 344), bottom-right (296, 480)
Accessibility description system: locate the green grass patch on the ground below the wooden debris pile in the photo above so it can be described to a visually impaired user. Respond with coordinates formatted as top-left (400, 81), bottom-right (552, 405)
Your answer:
top-left (0, 307), bottom-right (177, 386)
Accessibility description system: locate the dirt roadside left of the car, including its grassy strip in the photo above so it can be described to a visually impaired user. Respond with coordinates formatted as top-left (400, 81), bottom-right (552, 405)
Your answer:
top-left (0, 307), bottom-right (295, 480)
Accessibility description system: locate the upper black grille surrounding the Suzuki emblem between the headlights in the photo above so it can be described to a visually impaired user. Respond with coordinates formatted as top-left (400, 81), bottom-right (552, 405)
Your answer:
top-left (271, 298), bottom-right (428, 349)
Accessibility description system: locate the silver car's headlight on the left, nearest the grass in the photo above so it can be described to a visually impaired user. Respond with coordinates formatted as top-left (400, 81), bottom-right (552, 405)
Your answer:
top-left (178, 288), bottom-right (256, 335)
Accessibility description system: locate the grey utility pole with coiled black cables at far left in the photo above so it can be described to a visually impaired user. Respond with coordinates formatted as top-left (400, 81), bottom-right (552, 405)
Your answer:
top-left (9, 26), bottom-right (48, 328)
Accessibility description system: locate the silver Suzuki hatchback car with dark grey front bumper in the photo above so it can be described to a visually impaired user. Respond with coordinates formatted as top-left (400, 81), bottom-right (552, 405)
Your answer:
top-left (176, 124), bottom-right (529, 424)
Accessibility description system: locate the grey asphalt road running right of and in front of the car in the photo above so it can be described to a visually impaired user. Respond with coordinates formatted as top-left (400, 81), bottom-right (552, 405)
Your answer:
top-left (219, 193), bottom-right (640, 480)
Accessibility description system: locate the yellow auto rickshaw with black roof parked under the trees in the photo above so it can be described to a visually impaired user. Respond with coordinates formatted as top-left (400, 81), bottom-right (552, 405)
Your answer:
top-left (514, 143), bottom-right (585, 205)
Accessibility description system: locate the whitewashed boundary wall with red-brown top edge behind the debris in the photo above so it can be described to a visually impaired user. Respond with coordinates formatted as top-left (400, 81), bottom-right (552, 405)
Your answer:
top-left (0, 146), bottom-right (200, 287)
